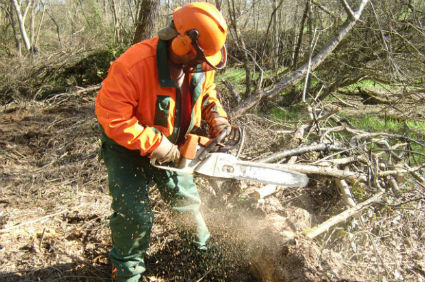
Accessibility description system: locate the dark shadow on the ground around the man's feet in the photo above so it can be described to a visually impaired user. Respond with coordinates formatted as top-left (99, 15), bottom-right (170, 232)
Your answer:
top-left (0, 240), bottom-right (256, 282)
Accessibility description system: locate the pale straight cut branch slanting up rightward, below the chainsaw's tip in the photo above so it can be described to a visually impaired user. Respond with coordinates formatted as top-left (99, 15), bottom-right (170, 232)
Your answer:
top-left (303, 191), bottom-right (384, 239)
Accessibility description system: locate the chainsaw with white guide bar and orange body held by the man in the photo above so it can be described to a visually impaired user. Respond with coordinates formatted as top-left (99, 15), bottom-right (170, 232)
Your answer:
top-left (150, 127), bottom-right (308, 187)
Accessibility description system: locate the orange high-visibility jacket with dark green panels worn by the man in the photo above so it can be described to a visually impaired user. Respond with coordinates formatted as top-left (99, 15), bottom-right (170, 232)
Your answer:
top-left (96, 37), bottom-right (227, 156)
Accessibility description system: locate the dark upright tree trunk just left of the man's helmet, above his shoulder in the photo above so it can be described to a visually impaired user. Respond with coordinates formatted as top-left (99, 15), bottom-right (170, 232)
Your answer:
top-left (133, 0), bottom-right (158, 44)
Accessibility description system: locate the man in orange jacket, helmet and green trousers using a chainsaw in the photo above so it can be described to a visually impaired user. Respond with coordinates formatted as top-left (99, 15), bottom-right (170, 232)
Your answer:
top-left (96, 2), bottom-right (230, 281)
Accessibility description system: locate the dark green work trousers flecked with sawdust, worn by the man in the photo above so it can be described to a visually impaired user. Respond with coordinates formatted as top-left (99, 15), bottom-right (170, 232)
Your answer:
top-left (102, 133), bottom-right (210, 282)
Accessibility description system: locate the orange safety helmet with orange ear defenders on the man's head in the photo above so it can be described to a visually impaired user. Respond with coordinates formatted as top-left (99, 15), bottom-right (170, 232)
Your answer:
top-left (158, 2), bottom-right (227, 69)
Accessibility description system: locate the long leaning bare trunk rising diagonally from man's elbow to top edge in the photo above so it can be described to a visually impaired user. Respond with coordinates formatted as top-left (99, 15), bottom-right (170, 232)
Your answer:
top-left (230, 0), bottom-right (369, 118)
